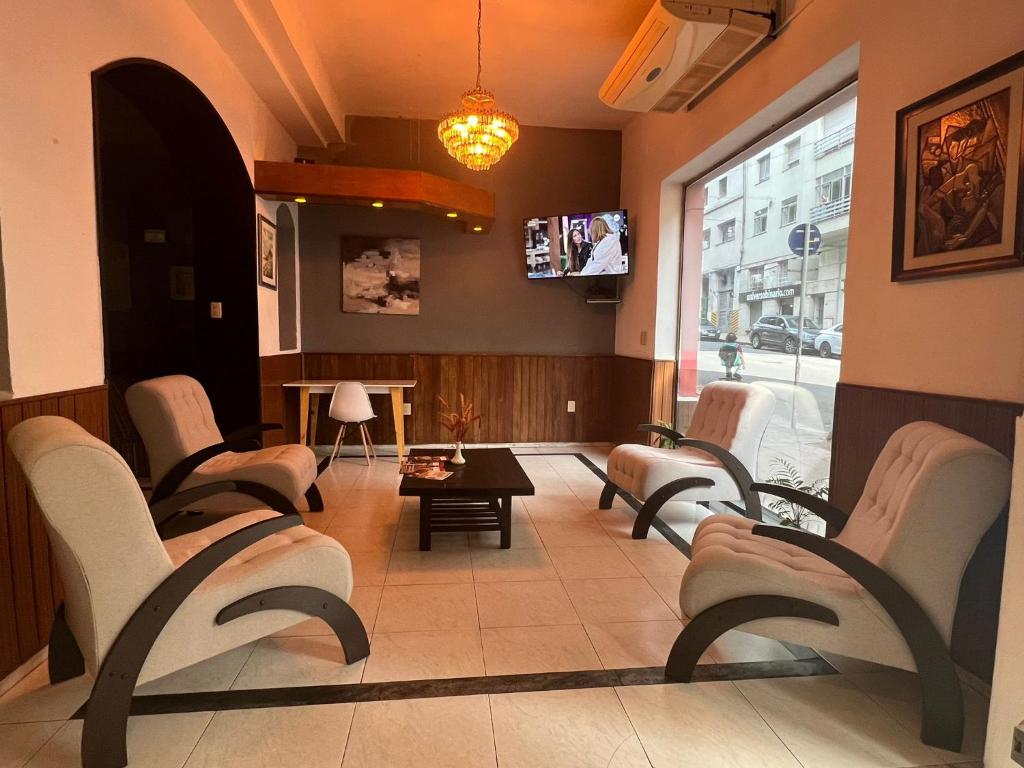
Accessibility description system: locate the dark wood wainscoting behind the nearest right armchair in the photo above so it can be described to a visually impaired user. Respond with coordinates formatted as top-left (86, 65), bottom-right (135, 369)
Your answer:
top-left (828, 383), bottom-right (1024, 680)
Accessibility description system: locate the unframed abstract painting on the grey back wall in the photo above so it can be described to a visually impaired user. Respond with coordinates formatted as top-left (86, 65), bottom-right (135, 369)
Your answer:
top-left (341, 237), bottom-right (420, 314)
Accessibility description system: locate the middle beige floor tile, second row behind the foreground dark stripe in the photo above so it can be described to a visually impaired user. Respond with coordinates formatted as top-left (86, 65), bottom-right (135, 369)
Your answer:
top-left (476, 582), bottom-right (580, 627)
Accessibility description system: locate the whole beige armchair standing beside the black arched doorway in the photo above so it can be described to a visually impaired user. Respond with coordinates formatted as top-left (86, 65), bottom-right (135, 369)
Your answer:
top-left (125, 376), bottom-right (324, 520)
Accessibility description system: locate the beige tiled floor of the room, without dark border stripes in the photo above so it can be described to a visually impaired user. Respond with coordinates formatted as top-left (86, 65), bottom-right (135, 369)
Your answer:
top-left (0, 446), bottom-right (987, 768)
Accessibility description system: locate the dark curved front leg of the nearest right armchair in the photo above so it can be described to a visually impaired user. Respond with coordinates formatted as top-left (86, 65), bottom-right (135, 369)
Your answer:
top-left (665, 595), bottom-right (839, 683)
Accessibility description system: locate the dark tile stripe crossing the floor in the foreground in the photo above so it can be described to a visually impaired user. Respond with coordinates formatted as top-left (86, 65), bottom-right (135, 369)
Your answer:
top-left (71, 658), bottom-right (837, 720)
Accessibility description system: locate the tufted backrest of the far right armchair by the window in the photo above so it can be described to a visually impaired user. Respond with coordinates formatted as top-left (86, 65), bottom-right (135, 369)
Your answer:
top-left (686, 381), bottom-right (775, 474)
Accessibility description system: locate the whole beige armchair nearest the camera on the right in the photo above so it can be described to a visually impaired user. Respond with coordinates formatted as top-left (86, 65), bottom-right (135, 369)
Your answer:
top-left (666, 422), bottom-right (1010, 752)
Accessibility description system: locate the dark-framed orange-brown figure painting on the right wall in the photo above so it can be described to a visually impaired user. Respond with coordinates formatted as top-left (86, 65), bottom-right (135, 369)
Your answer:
top-left (892, 53), bottom-right (1024, 281)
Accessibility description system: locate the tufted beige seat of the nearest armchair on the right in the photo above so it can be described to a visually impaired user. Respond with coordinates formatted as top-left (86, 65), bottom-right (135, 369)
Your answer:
top-left (679, 515), bottom-right (914, 670)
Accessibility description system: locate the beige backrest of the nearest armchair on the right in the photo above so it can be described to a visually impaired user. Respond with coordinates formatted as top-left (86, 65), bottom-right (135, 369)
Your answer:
top-left (836, 421), bottom-right (1011, 643)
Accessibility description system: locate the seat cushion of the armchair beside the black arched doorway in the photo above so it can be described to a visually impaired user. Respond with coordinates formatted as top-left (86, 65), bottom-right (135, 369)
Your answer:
top-left (181, 444), bottom-right (316, 510)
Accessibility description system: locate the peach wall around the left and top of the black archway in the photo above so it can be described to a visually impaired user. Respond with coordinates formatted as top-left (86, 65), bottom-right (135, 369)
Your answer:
top-left (0, 0), bottom-right (295, 396)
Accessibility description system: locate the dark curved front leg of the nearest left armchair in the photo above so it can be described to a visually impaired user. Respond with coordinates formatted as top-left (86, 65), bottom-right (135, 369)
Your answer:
top-left (215, 587), bottom-right (370, 664)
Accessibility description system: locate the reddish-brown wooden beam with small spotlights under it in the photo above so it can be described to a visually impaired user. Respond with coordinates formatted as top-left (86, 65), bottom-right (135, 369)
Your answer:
top-left (255, 160), bottom-right (495, 231)
